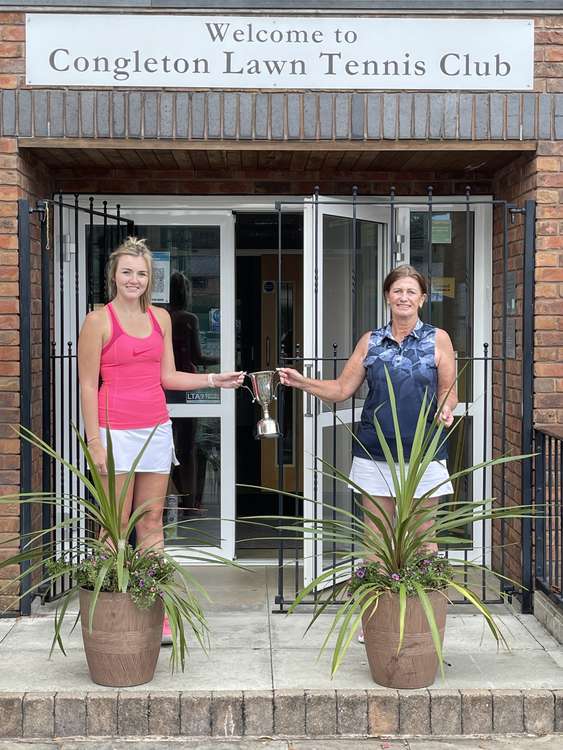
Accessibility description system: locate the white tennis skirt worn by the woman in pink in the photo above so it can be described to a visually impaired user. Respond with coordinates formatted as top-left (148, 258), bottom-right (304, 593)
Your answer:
top-left (100, 420), bottom-right (178, 474)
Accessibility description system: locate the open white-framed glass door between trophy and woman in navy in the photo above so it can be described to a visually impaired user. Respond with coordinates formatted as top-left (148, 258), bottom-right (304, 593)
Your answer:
top-left (303, 199), bottom-right (389, 585)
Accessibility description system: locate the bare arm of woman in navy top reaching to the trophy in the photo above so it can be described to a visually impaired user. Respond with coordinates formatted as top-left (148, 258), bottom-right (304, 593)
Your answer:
top-left (279, 332), bottom-right (371, 403)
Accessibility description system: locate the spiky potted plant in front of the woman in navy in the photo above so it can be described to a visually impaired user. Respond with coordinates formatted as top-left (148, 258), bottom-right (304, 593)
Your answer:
top-left (253, 373), bottom-right (532, 688)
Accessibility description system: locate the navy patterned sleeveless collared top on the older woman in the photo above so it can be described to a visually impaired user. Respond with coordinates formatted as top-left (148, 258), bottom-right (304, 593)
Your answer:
top-left (353, 320), bottom-right (447, 461)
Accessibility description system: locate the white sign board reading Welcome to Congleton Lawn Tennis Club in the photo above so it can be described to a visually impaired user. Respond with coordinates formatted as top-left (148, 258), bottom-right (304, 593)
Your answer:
top-left (26, 13), bottom-right (534, 90)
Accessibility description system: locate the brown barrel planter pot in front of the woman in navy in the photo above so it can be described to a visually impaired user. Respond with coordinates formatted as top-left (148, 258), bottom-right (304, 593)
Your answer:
top-left (363, 591), bottom-right (448, 688)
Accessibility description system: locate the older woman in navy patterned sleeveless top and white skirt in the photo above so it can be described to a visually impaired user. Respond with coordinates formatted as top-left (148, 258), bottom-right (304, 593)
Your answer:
top-left (280, 265), bottom-right (457, 568)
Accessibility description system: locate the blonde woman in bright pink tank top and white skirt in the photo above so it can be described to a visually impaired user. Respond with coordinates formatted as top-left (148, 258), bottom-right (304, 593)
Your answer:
top-left (78, 237), bottom-right (244, 641)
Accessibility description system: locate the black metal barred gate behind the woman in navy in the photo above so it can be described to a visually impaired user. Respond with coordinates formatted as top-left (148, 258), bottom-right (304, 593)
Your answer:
top-left (274, 188), bottom-right (536, 612)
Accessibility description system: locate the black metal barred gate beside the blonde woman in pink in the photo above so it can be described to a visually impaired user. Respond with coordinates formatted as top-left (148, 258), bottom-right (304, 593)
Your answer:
top-left (19, 195), bottom-right (133, 612)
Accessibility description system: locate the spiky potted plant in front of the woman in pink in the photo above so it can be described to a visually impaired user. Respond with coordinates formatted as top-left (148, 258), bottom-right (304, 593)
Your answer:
top-left (0, 427), bottom-right (235, 687)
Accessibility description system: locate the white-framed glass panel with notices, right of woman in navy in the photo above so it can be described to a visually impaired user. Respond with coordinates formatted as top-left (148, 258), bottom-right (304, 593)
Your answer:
top-left (398, 203), bottom-right (492, 559)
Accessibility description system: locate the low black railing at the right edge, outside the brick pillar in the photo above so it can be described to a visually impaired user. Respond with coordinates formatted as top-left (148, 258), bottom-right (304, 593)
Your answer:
top-left (534, 429), bottom-right (563, 609)
